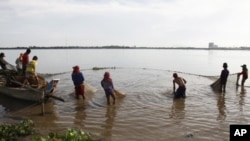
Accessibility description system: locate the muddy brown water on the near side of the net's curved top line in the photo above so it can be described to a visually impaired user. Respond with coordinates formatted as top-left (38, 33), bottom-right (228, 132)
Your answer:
top-left (0, 69), bottom-right (250, 141)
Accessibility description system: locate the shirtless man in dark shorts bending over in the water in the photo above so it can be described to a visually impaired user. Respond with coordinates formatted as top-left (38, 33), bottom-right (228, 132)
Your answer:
top-left (173, 73), bottom-right (187, 98)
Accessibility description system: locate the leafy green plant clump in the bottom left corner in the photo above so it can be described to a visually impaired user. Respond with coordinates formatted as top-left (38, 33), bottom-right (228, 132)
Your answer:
top-left (0, 119), bottom-right (35, 141)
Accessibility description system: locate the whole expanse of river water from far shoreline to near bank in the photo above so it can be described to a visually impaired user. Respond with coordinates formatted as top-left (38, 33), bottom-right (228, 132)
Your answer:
top-left (0, 49), bottom-right (250, 141)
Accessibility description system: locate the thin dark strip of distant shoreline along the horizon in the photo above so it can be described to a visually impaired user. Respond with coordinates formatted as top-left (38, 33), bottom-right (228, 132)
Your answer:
top-left (0, 46), bottom-right (250, 50)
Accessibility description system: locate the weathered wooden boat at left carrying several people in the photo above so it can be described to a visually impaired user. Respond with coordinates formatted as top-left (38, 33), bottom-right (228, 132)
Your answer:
top-left (0, 70), bottom-right (59, 102)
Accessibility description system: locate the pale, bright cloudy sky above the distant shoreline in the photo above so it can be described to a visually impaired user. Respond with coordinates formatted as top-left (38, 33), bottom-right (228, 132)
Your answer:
top-left (0, 0), bottom-right (250, 48)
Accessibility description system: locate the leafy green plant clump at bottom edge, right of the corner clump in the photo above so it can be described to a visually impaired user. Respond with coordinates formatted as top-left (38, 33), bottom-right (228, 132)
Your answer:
top-left (32, 129), bottom-right (97, 141)
